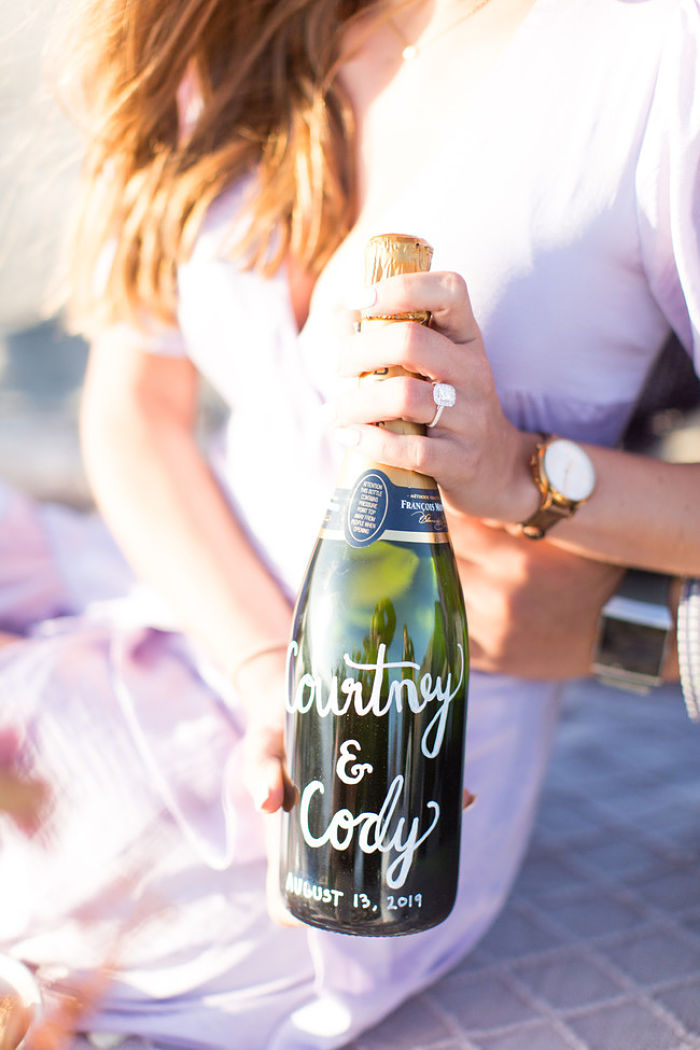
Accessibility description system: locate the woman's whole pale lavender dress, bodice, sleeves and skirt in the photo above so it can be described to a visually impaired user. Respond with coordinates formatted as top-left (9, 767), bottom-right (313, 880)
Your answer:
top-left (0, 0), bottom-right (700, 1050)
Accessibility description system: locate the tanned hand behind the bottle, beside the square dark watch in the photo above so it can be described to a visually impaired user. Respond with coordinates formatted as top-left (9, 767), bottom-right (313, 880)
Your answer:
top-left (449, 515), bottom-right (622, 679)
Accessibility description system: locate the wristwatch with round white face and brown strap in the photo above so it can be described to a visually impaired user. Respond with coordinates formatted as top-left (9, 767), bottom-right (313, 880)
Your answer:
top-left (521, 436), bottom-right (595, 540)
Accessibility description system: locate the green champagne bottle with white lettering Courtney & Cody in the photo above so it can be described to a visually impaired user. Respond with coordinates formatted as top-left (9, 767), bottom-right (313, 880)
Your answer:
top-left (280, 235), bottom-right (468, 937)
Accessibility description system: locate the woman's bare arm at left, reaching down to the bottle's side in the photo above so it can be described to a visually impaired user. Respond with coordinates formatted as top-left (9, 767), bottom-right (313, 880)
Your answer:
top-left (81, 338), bottom-right (292, 810)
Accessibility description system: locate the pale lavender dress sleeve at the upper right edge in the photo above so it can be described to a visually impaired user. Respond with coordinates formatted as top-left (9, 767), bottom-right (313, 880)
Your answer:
top-left (636, 0), bottom-right (700, 373)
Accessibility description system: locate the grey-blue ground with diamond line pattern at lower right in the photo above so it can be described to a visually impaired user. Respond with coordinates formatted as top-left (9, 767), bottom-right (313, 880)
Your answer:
top-left (344, 683), bottom-right (700, 1050)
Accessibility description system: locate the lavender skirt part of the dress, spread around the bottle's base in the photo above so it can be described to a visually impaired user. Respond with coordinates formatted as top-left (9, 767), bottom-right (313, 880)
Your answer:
top-left (0, 490), bottom-right (557, 1050)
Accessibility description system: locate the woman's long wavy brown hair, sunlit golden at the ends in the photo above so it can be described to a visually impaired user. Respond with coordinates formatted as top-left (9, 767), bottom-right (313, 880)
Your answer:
top-left (68, 0), bottom-right (379, 332)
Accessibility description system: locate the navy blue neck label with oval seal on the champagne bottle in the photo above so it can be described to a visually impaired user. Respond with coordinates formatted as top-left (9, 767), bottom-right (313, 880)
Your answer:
top-left (323, 468), bottom-right (447, 547)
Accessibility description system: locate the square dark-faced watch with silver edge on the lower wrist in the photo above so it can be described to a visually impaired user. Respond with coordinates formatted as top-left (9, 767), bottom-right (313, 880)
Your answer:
top-left (593, 569), bottom-right (674, 693)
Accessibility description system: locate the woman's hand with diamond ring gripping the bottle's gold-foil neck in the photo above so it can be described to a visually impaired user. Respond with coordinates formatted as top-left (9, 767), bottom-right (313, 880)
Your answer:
top-left (336, 273), bottom-right (537, 523)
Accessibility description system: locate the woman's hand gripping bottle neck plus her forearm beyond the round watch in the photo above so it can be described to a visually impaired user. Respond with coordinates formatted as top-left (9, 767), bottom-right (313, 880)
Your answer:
top-left (338, 273), bottom-right (700, 575)
